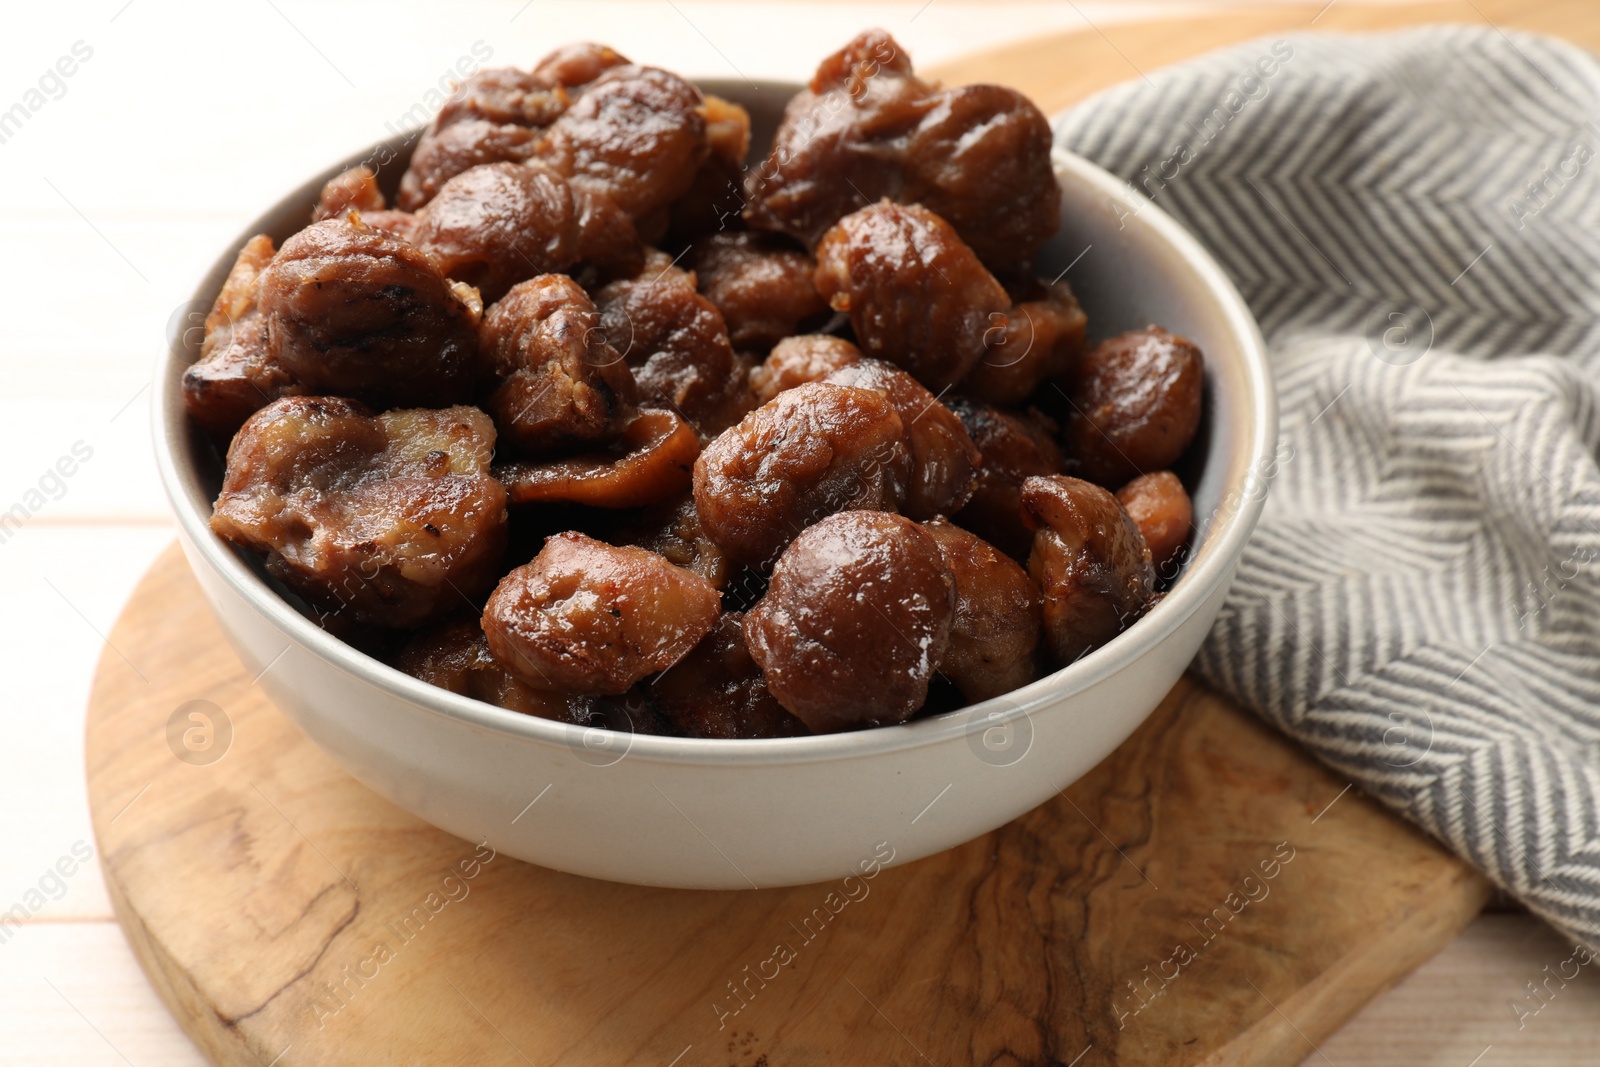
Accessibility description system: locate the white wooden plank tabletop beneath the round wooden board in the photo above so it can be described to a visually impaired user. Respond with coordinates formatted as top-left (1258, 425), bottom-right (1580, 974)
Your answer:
top-left (0, 0), bottom-right (1600, 1067)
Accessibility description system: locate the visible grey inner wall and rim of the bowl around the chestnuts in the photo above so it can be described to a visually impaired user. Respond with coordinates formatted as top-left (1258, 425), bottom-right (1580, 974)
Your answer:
top-left (155, 80), bottom-right (1275, 761)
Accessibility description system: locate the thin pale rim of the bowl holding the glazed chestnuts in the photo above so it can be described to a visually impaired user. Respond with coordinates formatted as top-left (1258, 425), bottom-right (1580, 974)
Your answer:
top-left (152, 120), bottom-right (1277, 766)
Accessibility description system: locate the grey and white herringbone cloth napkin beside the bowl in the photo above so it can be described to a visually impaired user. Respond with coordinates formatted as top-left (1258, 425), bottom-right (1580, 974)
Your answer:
top-left (1056, 27), bottom-right (1600, 945)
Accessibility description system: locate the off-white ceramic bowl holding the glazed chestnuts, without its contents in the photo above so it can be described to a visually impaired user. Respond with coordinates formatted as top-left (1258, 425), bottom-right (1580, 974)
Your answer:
top-left (155, 82), bottom-right (1277, 889)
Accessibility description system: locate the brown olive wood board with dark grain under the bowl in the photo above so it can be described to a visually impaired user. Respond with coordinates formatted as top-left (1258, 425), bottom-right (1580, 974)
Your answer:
top-left (86, 0), bottom-right (1600, 1067)
